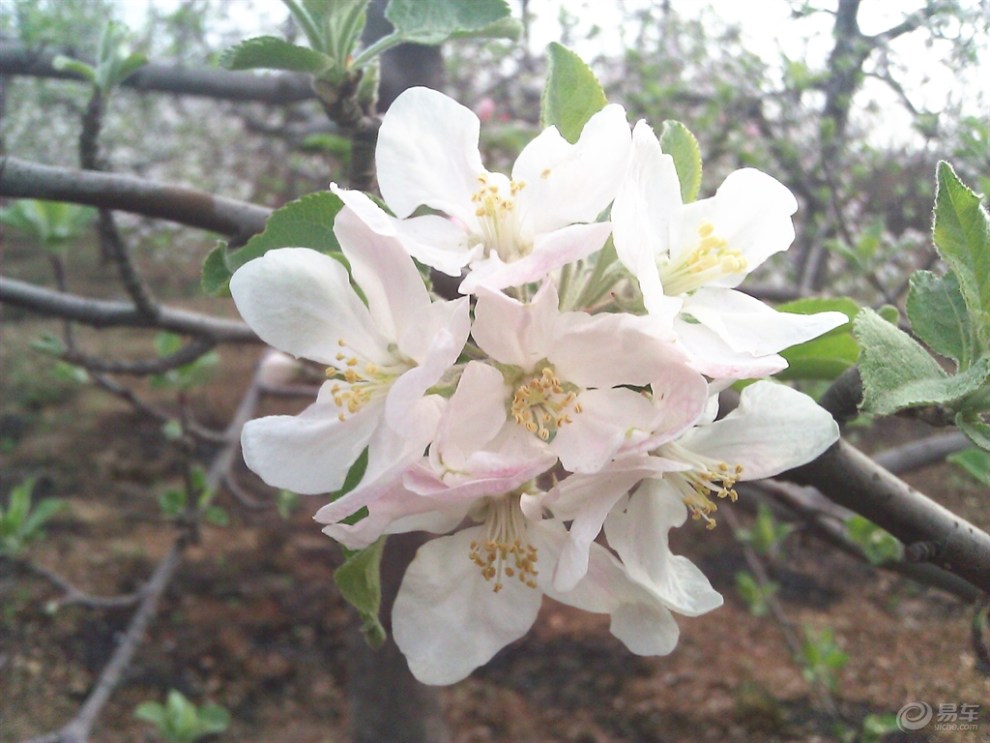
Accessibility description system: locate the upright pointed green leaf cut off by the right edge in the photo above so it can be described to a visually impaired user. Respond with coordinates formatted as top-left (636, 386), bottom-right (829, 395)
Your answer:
top-left (933, 161), bottom-right (990, 348)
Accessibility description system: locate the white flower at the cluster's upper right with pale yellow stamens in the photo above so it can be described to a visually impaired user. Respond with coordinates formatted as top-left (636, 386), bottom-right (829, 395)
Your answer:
top-left (611, 121), bottom-right (848, 379)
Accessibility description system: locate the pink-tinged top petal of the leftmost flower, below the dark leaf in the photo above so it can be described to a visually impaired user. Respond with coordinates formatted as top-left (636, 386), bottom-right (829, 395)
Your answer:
top-left (333, 207), bottom-right (430, 339)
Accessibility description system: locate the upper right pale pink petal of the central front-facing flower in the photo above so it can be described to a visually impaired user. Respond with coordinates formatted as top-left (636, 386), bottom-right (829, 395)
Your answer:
top-left (547, 312), bottom-right (686, 387)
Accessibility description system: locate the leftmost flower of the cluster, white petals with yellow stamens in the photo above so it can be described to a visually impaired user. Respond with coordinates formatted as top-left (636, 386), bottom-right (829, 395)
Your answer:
top-left (230, 209), bottom-right (470, 493)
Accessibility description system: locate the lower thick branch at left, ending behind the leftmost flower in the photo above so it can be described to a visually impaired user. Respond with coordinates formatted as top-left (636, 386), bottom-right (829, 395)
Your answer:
top-left (0, 276), bottom-right (261, 343)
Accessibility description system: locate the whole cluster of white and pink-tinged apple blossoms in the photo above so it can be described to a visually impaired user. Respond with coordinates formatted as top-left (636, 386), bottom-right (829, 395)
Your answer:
top-left (230, 88), bottom-right (846, 684)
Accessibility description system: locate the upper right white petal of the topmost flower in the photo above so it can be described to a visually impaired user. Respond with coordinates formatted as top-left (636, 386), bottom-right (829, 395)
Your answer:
top-left (512, 104), bottom-right (630, 235)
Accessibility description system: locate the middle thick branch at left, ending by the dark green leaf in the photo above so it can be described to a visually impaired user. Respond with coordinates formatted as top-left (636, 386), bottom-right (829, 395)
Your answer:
top-left (0, 157), bottom-right (271, 239)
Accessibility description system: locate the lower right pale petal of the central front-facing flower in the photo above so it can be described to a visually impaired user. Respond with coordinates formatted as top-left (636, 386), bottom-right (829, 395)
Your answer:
top-left (550, 387), bottom-right (660, 472)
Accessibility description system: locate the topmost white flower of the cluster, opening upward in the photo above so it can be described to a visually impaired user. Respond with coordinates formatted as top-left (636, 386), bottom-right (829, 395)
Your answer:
top-left (336, 88), bottom-right (630, 293)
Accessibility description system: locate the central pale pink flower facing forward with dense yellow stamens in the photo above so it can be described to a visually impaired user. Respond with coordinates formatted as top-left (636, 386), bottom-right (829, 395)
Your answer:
top-left (472, 281), bottom-right (707, 472)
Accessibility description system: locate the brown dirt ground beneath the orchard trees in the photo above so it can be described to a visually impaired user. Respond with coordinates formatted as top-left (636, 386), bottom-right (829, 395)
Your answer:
top-left (0, 234), bottom-right (990, 743)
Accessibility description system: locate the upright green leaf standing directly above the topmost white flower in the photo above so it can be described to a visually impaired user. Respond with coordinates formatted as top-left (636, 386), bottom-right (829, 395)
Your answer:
top-left (540, 42), bottom-right (608, 144)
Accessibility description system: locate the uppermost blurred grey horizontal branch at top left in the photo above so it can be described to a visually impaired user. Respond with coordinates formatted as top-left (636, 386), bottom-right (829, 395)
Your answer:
top-left (0, 41), bottom-right (315, 104)
